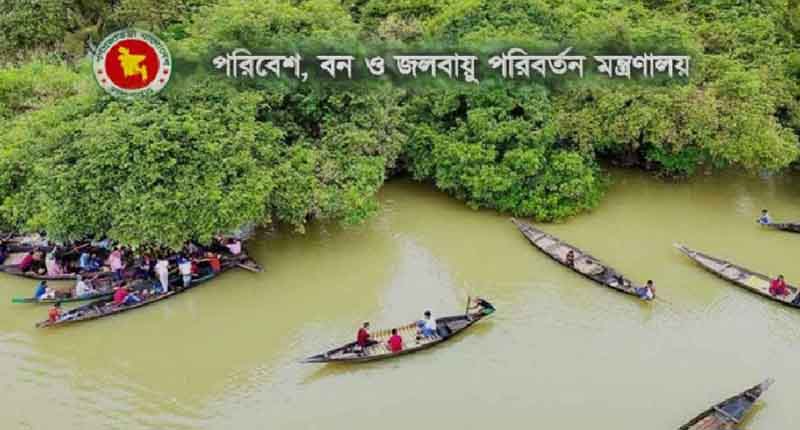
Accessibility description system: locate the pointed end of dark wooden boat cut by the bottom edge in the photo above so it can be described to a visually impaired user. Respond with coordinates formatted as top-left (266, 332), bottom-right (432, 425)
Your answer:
top-left (678, 379), bottom-right (774, 430)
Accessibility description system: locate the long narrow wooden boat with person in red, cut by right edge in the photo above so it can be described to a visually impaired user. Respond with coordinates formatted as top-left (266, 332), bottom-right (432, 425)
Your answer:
top-left (675, 244), bottom-right (800, 308)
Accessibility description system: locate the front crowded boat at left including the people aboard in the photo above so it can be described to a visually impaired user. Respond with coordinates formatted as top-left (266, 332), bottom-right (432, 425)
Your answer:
top-left (36, 253), bottom-right (261, 328)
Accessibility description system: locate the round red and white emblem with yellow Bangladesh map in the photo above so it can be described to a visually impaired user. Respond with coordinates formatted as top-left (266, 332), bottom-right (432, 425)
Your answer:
top-left (94, 29), bottom-right (172, 97)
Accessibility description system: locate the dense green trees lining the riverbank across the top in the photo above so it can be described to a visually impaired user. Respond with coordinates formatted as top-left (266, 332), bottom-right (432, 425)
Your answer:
top-left (0, 0), bottom-right (800, 248)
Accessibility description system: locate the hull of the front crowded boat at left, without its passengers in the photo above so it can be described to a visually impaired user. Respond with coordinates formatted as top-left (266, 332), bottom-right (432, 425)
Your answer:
top-left (36, 254), bottom-right (259, 328)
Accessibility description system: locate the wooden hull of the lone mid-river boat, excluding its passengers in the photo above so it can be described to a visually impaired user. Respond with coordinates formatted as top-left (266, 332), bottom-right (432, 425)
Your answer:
top-left (303, 300), bottom-right (495, 363)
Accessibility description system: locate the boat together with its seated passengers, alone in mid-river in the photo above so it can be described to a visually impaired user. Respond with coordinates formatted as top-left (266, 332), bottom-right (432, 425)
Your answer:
top-left (303, 298), bottom-right (495, 363)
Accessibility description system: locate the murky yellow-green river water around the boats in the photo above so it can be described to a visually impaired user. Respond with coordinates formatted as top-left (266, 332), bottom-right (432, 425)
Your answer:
top-left (0, 171), bottom-right (800, 430)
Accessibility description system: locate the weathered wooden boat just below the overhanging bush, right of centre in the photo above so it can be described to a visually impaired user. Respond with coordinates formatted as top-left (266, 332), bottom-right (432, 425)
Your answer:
top-left (511, 218), bottom-right (644, 300)
